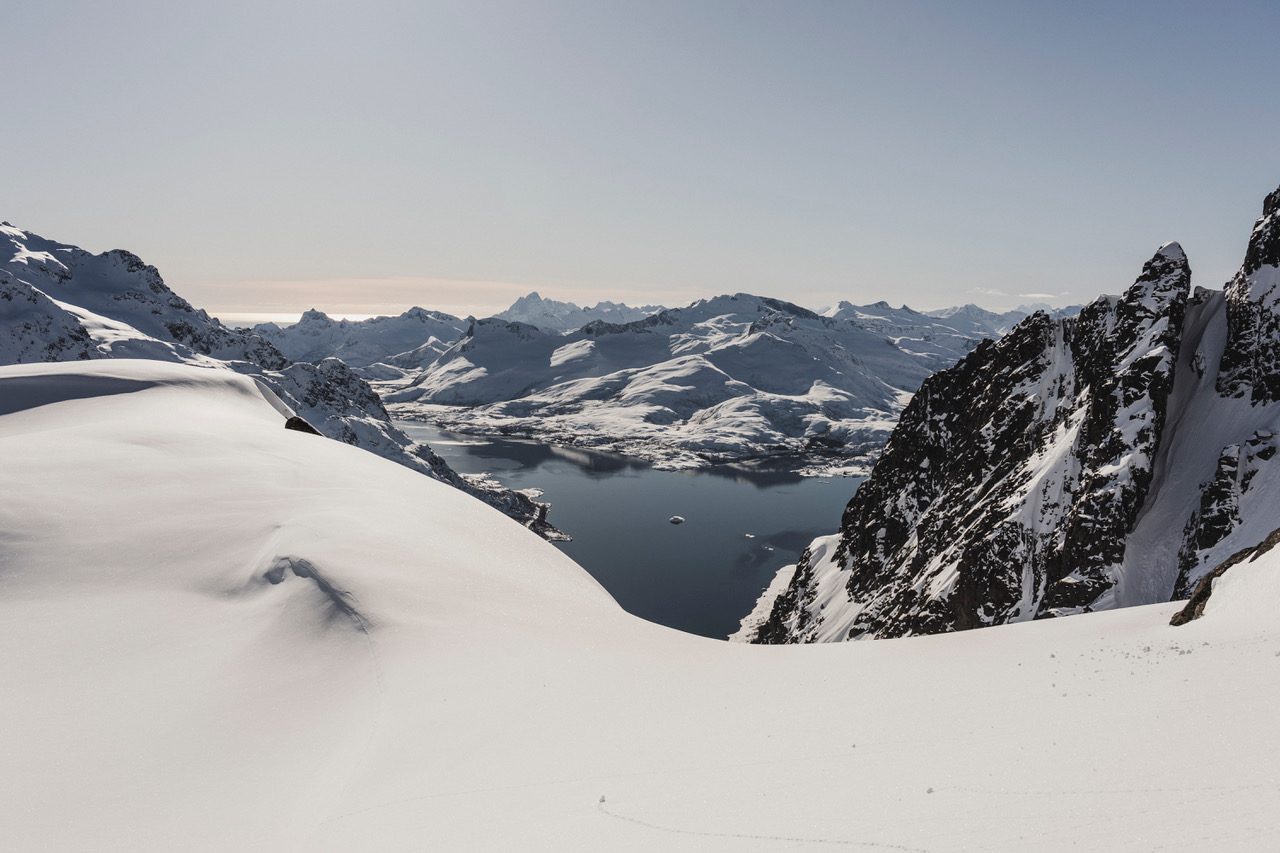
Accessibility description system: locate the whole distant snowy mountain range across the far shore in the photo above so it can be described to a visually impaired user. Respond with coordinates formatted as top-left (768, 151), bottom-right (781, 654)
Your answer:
top-left (235, 292), bottom-right (1079, 473)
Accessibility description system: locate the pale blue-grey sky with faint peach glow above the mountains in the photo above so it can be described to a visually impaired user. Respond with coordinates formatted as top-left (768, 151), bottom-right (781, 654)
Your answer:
top-left (0, 0), bottom-right (1280, 319)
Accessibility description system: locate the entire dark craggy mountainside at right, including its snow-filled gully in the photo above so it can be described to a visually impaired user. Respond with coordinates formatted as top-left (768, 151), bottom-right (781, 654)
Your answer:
top-left (740, 184), bottom-right (1280, 643)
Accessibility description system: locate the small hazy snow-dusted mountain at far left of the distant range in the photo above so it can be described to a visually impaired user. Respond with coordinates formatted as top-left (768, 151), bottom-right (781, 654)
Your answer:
top-left (253, 307), bottom-right (467, 369)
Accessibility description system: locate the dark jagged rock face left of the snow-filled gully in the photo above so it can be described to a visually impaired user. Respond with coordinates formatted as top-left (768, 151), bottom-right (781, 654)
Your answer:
top-left (754, 243), bottom-right (1190, 642)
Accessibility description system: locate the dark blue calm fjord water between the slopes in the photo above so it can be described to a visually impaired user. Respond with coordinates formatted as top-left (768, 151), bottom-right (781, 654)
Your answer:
top-left (397, 421), bottom-right (860, 639)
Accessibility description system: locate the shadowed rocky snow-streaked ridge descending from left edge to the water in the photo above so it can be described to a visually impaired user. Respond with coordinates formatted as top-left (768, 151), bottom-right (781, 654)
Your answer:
top-left (0, 223), bottom-right (559, 535)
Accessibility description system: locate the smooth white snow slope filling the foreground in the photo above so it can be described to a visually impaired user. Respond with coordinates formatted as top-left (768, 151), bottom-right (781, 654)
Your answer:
top-left (0, 360), bottom-right (1280, 850)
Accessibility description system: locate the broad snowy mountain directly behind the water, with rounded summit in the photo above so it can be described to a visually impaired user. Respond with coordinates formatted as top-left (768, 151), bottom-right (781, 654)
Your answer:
top-left (385, 293), bottom-right (1029, 470)
